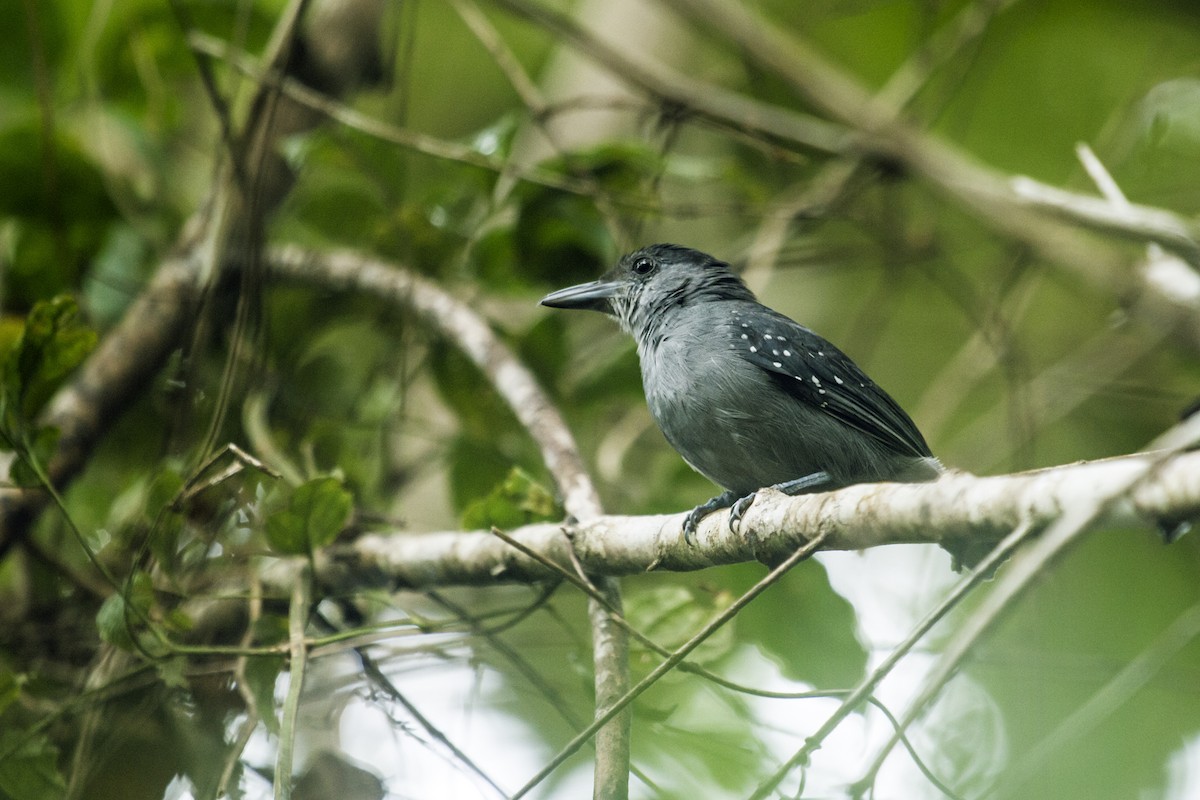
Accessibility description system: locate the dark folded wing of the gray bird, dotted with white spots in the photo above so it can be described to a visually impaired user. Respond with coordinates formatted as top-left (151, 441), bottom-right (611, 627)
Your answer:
top-left (731, 308), bottom-right (932, 458)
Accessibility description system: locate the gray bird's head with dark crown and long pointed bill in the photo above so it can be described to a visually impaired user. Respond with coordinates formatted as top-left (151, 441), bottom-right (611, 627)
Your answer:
top-left (541, 245), bottom-right (754, 341)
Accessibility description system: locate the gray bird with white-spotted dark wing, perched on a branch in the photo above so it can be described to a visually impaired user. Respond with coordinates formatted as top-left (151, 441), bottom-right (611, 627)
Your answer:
top-left (541, 245), bottom-right (942, 542)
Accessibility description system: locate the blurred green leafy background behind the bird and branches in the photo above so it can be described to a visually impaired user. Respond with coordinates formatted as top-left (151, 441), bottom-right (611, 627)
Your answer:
top-left (0, 0), bottom-right (1200, 799)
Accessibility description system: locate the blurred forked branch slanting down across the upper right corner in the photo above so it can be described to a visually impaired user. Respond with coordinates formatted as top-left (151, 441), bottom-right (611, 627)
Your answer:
top-left (497, 0), bottom-right (1200, 349)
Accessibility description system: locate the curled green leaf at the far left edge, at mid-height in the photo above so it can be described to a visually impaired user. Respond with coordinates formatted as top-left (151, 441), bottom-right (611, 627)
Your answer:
top-left (2, 295), bottom-right (96, 426)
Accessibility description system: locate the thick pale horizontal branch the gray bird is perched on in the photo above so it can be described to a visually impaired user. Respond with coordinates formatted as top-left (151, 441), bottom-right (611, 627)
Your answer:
top-left (320, 452), bottom-right (1200, 588)
